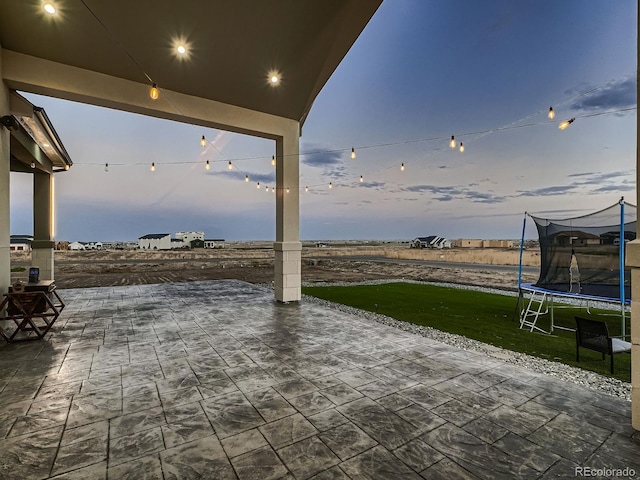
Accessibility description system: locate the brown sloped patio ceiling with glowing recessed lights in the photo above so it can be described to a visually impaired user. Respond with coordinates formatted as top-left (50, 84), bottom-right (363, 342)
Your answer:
top-left (0, 0), bottom-right (382, 122)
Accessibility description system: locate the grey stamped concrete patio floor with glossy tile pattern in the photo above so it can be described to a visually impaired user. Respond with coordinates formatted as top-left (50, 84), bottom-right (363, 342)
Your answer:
top-left (0, 281), bottom-right (640, 480)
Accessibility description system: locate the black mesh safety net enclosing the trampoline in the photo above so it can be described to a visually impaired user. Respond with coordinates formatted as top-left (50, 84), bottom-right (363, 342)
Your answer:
top-left (529, 201), bottom-right (637, 300)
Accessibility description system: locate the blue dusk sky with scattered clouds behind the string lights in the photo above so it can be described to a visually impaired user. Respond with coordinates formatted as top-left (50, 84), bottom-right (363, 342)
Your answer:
top-left (11, 0), bottom-right (637, 241)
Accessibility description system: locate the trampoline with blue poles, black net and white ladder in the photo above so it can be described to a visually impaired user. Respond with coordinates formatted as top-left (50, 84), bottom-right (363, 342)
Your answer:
top-left (518, 198), bottom-right (637, 338)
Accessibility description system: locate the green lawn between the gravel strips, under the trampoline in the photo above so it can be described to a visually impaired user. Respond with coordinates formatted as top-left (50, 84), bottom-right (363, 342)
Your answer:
top-left (302, 283), bottom-right (631, 382)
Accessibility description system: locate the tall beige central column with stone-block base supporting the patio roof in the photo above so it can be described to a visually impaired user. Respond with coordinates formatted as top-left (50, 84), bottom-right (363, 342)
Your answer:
top-left (273, 123), bottom-right (302, 302)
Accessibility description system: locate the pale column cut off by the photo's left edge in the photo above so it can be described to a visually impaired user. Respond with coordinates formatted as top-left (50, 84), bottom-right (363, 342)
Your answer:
top-left (0, 51), bottom-right (11, 298)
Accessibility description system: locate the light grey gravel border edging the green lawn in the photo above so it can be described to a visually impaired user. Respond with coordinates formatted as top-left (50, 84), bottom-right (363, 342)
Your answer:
top-left (302, 279), bottom-right (631, 400)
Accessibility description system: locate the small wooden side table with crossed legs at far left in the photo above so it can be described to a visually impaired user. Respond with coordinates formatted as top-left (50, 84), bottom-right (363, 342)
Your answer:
top-left (0, 280), bottom-right (65, 343)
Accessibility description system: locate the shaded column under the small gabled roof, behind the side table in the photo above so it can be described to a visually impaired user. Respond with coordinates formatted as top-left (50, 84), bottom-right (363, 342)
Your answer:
top-left (31, 173), bottom-right (55, 280)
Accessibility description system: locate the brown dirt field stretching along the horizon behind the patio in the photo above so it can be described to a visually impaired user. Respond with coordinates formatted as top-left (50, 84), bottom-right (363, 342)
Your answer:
top-left (11, 243), bottom-right (538, 288)
